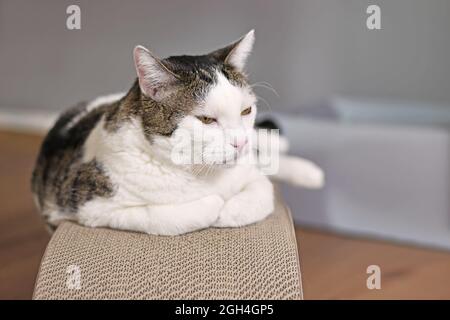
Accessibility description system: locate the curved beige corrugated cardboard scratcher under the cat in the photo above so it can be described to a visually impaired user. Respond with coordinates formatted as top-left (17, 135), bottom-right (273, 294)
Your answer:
top-left (34, 192), bottom-right (303, 299)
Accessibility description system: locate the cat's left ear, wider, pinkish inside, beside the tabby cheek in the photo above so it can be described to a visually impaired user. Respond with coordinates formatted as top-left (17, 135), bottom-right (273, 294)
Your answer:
top-left (134, 46), bottom-right (177, 101)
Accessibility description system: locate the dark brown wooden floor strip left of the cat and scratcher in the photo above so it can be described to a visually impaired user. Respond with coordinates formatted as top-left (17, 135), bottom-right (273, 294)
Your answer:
top-left (0, 132), bottom-right (49, 299)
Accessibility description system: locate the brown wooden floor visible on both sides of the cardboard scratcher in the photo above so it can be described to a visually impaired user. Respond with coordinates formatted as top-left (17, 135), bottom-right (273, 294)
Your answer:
top-left (0, 132), bottom-right (450, 299)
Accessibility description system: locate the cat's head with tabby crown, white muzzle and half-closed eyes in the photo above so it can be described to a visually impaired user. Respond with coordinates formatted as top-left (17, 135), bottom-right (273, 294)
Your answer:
top-left (134, 30), bottom-right (256, 168)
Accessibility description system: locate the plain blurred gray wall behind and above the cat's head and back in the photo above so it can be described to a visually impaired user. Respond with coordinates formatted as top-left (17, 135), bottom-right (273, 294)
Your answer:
top-left (0, 0), bottom-right (450, 109)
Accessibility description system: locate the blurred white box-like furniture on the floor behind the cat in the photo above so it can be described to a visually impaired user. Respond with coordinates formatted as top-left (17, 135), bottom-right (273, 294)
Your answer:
top-left (268, 98), bottom-right (450, 249)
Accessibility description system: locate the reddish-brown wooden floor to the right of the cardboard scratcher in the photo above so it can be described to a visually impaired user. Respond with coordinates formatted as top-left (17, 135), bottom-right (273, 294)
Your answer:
top-left (296, 228), bottom-right (450, 299)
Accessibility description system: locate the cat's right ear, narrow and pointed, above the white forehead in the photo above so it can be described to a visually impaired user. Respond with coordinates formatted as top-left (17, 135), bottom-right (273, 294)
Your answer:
top-left (210, 30), bottom-right (255, 71)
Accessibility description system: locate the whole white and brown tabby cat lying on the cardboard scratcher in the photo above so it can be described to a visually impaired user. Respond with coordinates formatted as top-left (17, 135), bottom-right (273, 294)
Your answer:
top-left (32, 30), bottom-right (323, 235)
